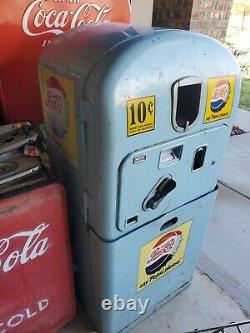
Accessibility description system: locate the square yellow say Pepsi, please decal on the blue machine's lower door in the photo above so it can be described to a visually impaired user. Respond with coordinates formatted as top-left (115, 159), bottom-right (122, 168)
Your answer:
top-left (137, 221), bottom-right (192, 291)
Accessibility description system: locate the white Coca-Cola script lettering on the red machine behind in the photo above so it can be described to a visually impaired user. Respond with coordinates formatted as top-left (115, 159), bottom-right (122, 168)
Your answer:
top-left (22, 0), bottom-right (112, 36)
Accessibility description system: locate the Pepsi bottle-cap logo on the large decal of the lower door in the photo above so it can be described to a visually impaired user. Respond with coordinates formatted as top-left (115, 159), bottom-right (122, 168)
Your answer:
top-left (145, 230), bottom-right (182, 274)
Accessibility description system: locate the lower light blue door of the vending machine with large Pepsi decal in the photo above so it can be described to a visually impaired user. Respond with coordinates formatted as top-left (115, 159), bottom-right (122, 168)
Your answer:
top-left (87, 190), bottom-right (217, 333)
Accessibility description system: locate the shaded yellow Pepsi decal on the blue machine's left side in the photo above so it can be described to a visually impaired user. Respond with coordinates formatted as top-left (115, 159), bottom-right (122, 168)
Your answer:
top-left (39, 66), bottom-right (78, 167)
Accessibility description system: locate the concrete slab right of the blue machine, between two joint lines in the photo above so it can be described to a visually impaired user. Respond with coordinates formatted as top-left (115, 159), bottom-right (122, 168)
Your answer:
top-left (198, 186), bottom-right (250, 316)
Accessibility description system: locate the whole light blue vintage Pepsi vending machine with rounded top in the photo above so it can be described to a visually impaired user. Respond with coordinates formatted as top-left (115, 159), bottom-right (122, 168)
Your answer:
top-left (39, 24), bottom-right (240, 333)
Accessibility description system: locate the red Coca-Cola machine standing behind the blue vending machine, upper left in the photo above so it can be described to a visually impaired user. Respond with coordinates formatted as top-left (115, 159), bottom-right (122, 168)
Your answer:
top-left (0, 0), bottom-right (130, 124)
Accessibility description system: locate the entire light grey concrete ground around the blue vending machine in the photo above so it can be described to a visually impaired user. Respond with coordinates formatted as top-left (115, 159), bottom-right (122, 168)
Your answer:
top-left (58, 111), bottom-right (250, 333)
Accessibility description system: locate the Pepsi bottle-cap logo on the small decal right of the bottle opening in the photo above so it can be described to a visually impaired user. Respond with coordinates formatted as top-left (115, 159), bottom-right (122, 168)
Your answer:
top-left (211, 80), bottom-right (230, 112)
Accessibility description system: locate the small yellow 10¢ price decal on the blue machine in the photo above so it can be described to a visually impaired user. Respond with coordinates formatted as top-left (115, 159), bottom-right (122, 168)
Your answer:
top-left (127, 96), bottom-right (155, 136)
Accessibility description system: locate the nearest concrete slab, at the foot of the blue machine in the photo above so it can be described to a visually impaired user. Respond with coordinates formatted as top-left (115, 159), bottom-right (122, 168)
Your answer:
top-left (59, 270), bottom-right (248, 333)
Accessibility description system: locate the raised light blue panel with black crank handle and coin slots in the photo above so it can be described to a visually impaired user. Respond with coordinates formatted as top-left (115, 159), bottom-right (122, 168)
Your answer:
top-left (117, 125), bottom-right (230, 231)
